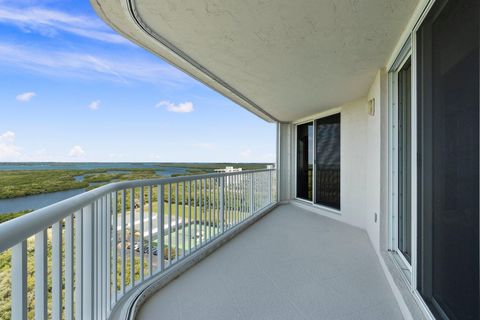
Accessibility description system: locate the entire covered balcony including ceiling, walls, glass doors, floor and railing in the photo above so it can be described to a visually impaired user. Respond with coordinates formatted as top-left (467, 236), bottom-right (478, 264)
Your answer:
top-left (0, 0), bottom-right (480, 320)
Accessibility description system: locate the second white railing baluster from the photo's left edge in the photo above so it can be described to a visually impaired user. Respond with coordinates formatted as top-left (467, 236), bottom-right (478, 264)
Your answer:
top-left (34, 230), bottom-right (48, 320)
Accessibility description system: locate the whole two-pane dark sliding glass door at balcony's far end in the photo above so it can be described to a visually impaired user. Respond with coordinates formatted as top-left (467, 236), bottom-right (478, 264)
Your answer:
top-left (297, 114), bottom-right (340, 210)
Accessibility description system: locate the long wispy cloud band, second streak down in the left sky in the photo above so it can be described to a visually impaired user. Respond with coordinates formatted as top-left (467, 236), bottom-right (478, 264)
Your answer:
top-left (0, 42), bottom-right (192, 85)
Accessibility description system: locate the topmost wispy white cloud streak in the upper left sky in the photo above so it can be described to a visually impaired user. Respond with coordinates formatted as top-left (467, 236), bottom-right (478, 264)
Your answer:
top-left (0, 5), bottom-right (130, 44)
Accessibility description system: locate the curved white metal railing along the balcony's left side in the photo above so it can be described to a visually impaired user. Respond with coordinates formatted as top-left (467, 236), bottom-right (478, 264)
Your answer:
top-left (0, 169), bottom-right (277, 319)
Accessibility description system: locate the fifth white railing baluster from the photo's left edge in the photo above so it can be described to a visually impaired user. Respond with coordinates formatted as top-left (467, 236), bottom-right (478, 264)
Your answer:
top-left (74, 210), bottom-right (83, 319)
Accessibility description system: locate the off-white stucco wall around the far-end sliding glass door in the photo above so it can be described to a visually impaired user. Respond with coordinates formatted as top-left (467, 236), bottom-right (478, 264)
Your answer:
top-left (288, 71), bottom-right (387, 251)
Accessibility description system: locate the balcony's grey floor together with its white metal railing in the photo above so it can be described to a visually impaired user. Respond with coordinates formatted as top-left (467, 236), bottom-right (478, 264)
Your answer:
top-left (0, 169), bottom-right (402, 319)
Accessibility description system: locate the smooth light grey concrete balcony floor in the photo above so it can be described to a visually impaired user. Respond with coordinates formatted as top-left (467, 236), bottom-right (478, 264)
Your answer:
top-left (137, 205), bottom-right (403, 320)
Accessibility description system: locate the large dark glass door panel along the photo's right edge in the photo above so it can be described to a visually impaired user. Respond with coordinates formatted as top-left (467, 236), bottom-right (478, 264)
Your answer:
top-left (417, 0), bottom-right (480, 320)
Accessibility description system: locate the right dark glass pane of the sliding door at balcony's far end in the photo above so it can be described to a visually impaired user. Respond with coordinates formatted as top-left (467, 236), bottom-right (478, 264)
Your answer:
top-left (315, 114), bottom-right (340, 209)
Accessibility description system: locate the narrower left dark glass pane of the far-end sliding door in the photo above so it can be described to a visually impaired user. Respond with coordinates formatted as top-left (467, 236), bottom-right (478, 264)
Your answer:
top-left (297, 122), bottom-right (313, 201)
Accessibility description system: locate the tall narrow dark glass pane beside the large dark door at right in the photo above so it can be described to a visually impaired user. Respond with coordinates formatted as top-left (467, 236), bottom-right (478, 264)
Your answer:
top-left (398, 58), bottom-right (412, 263)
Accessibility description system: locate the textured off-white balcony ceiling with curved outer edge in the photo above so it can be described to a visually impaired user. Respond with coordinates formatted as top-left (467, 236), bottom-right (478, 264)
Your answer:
top-left (91, 0), bottom-right (418, 121)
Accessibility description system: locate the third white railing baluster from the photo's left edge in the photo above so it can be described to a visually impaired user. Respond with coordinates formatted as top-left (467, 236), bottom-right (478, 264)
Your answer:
top-left (52, 220), bottom-right (62, 320)
